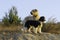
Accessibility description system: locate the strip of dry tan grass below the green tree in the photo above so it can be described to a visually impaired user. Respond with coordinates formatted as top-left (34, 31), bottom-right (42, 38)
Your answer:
top-left (0, 25), bottom-right (22, 31)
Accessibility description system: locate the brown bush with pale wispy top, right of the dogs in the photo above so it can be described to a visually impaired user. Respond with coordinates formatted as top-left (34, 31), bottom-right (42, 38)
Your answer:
top-left (42, 18), bottom-right (60, 33)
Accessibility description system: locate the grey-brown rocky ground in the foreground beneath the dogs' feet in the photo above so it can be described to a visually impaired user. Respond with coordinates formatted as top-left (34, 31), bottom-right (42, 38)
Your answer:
top-left (0, 32), bottom-right (60, 40)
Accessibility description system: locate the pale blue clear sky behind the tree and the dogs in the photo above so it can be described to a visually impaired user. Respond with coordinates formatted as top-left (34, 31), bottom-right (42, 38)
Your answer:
top-left (0, 0), bottom-right (60, 22)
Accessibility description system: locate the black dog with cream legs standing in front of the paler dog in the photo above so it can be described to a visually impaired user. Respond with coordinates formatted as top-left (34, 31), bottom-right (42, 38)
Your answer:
top-left (25, 16), bottom-right (45, 33)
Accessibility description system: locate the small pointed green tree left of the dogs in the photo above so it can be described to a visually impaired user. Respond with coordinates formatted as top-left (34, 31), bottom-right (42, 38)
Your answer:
top-left (3, 6), bottom-right (21, 25)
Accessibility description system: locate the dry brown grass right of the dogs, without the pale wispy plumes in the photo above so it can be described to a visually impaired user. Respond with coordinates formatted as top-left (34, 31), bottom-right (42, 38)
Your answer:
top-left (42, 23), bottom-right (60, 33)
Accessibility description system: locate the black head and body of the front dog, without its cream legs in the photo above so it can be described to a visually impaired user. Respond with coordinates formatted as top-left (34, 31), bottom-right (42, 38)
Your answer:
top-left (25, 16), bottom-right (45, 33)
